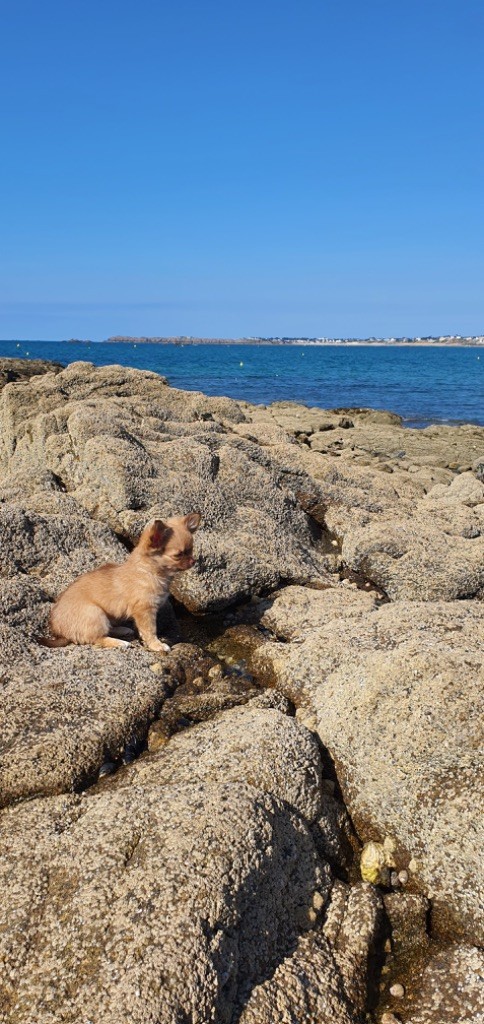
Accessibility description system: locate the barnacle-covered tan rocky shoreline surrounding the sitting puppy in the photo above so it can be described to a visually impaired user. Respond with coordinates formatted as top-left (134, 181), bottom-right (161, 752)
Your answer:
top-left (0, 359), bottom-right (484, 1024)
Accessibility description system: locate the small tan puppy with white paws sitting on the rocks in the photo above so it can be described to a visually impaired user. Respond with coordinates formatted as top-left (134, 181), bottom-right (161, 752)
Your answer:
top-left (43, 512), bottom-right (201, 651)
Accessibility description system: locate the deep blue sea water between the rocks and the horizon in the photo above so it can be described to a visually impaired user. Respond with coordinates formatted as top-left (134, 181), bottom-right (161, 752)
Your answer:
top-left (0, 341), bottom-right (484, 427)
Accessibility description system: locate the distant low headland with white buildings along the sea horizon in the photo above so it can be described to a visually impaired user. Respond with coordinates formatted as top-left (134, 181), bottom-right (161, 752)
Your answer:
top-left (98, 334), bottom-right (484, 345)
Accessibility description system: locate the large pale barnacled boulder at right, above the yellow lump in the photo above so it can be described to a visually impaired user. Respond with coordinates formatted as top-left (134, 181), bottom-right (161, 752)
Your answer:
top-left (253, 588), bottom-right (484, 942)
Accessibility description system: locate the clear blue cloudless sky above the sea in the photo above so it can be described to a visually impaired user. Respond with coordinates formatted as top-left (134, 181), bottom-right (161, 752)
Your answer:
top-left (0, 0), bottom-right (484, 339)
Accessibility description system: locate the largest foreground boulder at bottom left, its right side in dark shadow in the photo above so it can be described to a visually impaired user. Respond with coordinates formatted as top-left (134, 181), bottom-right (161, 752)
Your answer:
top-left (0, 708), bottom-right (380, 1024)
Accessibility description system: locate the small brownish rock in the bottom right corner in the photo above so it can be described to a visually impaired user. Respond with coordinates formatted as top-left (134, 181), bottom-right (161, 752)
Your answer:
top-left (406, 945), bottom-right (484, 1024)
